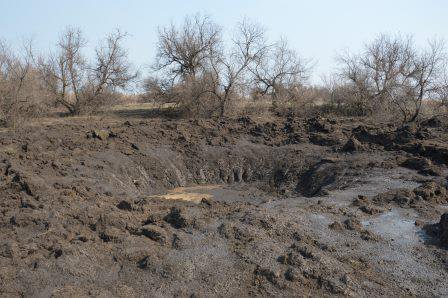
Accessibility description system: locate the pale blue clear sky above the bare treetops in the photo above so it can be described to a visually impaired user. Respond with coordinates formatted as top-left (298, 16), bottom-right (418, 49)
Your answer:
top-left (0, 0), bottom-right (448, 82)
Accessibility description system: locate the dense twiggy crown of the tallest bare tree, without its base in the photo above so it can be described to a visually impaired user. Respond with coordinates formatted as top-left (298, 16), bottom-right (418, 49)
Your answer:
top-left (154, 15), bottom-right (221, 83)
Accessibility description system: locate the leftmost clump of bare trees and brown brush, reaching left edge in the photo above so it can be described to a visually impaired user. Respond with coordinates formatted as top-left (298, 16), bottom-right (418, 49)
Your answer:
top-left (0, 28), bottom-right (137, 126)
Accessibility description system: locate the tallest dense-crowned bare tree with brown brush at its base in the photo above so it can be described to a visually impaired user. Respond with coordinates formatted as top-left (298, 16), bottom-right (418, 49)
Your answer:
top-left (145, 14), bottom-right (221, 115)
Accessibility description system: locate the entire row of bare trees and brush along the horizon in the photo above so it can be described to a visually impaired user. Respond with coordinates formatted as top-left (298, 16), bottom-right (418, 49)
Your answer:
top-left (0, 15), bottom-right (448, 125)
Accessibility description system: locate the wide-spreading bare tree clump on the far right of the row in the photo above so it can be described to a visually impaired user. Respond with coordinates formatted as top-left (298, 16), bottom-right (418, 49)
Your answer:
top-left (339, 34), bottom-right (445, 122)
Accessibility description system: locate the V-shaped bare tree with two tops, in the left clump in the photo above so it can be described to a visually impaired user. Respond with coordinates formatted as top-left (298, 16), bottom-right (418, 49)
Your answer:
top-left (38, 28), bottom-right (137, 115)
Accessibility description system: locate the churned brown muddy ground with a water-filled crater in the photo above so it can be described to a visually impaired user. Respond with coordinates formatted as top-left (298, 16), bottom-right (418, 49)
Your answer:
top-left (0, 113), bottom-right (448, 297)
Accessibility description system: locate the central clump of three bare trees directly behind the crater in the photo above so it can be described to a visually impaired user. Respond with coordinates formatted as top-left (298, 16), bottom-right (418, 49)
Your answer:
top-left (146, 16), bottom-right (307, 116)
